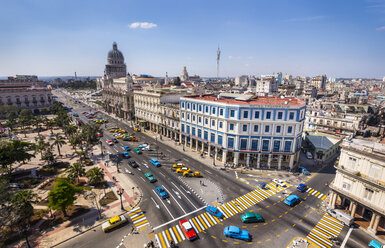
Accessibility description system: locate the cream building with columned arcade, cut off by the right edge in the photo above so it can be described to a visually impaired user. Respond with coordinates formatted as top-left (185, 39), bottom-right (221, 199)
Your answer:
top-left (329, 138), bottom-right (385, 237)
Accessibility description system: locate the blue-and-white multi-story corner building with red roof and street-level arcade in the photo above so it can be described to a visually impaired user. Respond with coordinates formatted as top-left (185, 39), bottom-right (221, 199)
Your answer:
top-left (180, 93), bottom-right (306, 169)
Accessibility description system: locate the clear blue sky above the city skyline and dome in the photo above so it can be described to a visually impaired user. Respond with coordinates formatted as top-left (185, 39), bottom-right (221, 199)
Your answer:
top-left (0, 0), bottom-right (385, 78)
